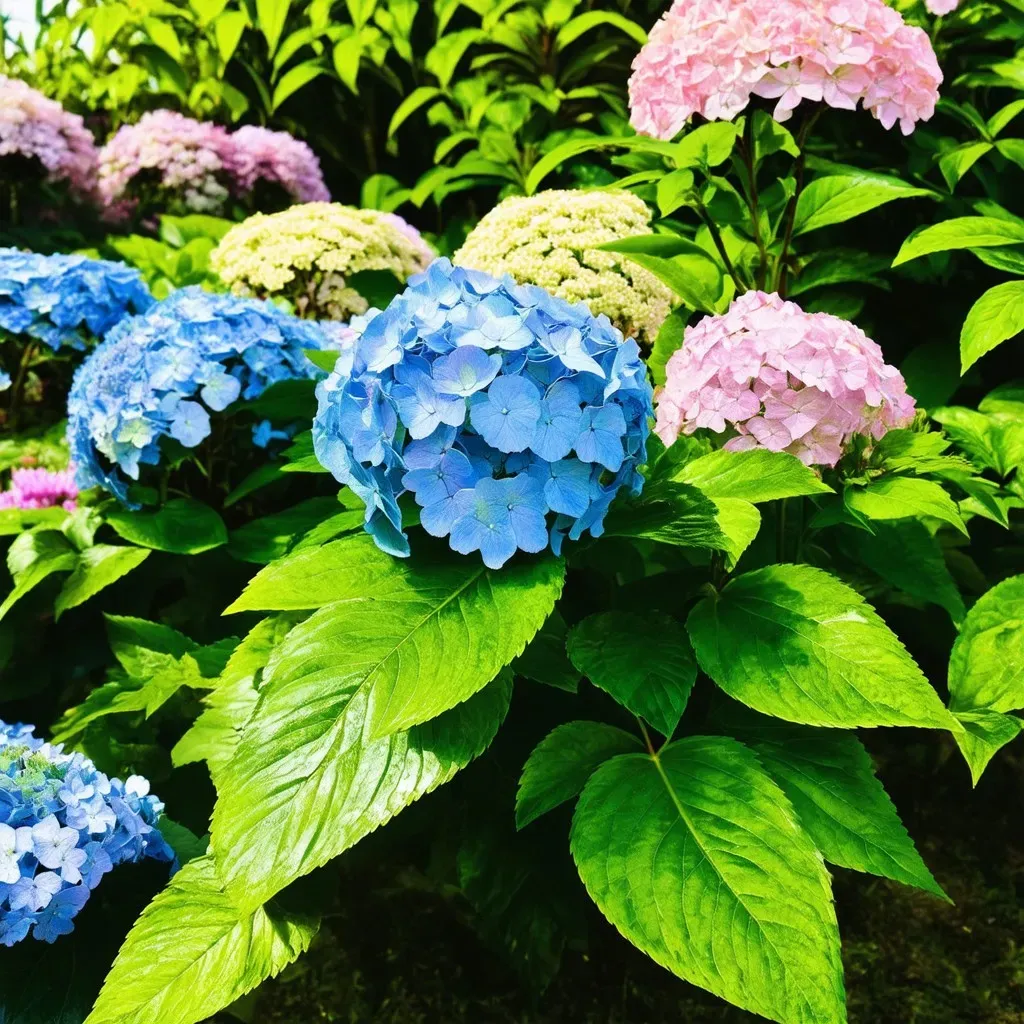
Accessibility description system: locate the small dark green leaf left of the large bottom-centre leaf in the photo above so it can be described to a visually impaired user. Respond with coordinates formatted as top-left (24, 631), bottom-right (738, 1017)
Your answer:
top-left (515, 722), bottom-right (643, 828)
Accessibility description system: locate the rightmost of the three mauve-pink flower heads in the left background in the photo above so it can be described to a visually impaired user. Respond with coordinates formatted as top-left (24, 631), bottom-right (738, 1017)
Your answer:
top-left (227, 125), bottom-right (331, 203)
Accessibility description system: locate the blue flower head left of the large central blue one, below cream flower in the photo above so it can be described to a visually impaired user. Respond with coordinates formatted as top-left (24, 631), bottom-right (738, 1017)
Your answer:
top-left (68, 288), bottom-right (339, 503)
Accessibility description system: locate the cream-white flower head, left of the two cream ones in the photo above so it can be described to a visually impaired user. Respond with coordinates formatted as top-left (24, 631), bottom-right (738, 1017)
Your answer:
top-left (210, 203), bottom-right (434, 321)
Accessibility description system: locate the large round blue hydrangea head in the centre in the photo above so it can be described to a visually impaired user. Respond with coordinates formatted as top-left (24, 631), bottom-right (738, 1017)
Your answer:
top-left (313, 259), bottom-right (652, 568)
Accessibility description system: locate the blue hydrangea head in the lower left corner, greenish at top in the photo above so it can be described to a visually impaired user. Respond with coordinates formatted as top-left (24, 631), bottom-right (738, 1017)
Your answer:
top-left (0, 721), bottom-right (174, 946)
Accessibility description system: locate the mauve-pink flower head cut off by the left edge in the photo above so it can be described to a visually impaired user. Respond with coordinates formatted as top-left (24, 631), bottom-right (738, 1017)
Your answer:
top-left (0, 75), bottom-right (96, 196)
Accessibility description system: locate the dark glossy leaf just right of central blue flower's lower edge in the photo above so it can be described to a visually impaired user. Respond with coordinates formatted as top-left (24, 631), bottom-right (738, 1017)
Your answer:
top-left (604, 482), bottom-right (728, 549)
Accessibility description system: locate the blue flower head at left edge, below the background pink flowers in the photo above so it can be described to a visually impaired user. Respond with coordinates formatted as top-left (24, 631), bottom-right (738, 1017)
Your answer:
top-left (0, 249), bottom-right (153, 350)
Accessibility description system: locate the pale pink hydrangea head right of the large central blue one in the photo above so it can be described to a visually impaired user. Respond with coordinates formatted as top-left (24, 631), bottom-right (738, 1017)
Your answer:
top-left (654, 292), bottom-right (914, 466)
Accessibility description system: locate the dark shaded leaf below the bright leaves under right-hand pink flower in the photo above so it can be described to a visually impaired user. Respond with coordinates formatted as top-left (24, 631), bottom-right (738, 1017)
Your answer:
top-left (848, 519), bottom-right (967, 625)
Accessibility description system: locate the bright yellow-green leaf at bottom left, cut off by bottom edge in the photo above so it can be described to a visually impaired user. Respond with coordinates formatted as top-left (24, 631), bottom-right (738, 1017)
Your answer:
top-left (86, 856), bottom-right (318, 1024)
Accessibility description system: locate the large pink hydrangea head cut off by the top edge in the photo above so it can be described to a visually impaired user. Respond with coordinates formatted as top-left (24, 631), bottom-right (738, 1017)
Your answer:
top-left (630, 0), bottom-right (943, 139)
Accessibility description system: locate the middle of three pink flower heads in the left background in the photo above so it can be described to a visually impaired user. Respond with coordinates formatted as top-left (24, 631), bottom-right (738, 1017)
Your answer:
top-left (99, 111), bottom-right (230, 213)
